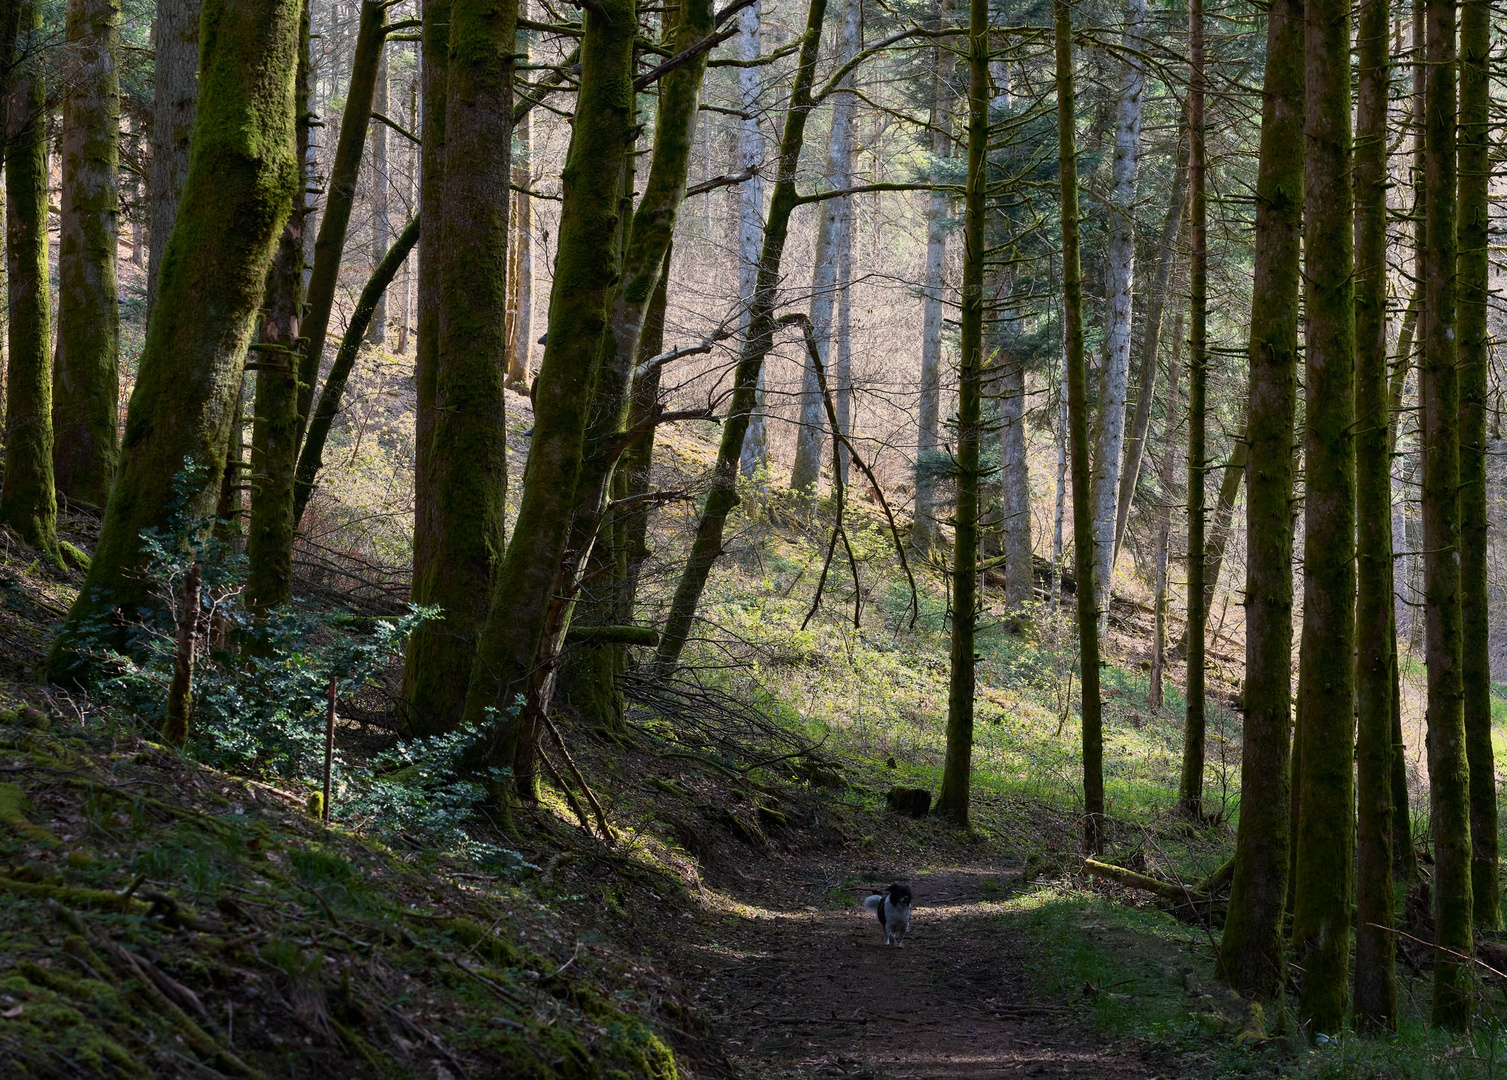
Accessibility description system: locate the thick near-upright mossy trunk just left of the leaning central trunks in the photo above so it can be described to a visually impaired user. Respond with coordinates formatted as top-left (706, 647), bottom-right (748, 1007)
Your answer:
top-left (400, 0), bottom-right (518, 735)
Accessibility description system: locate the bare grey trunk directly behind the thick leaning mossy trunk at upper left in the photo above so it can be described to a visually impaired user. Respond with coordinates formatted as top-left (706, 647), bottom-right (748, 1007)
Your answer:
top-left (146, 0), bottom-right (203, 322)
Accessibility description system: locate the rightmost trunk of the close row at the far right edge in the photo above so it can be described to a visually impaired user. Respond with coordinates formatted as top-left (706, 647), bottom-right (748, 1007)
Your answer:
top-left (1456, 0), bottom-right (1502, 929)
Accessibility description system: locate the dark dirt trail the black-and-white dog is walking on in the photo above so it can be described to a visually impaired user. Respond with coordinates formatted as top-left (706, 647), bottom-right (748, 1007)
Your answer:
top-left (687, 860), bottom-right (1166, 1080)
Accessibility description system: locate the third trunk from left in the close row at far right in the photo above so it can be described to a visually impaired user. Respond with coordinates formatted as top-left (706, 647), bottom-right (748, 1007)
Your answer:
top-left (1355, 0), bottom-right (1397, 1032)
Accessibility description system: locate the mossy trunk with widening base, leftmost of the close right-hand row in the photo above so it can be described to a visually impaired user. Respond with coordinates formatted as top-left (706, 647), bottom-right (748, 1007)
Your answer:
top-left (1219, 0), bottom-right (1304, 999)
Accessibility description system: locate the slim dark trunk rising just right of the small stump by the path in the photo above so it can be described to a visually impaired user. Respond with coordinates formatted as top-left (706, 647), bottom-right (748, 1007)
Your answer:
top-left (937, 0), bottom-right (994, 825)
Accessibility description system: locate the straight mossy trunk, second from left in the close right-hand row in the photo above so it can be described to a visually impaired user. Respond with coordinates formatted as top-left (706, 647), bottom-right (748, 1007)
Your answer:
top-left (1289, 0), bottom-right (1355, 1036)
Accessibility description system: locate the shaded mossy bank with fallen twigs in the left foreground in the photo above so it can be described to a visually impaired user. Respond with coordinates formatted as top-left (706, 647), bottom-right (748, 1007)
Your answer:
top-left (0, 709), bottom-right (693, 1080)
